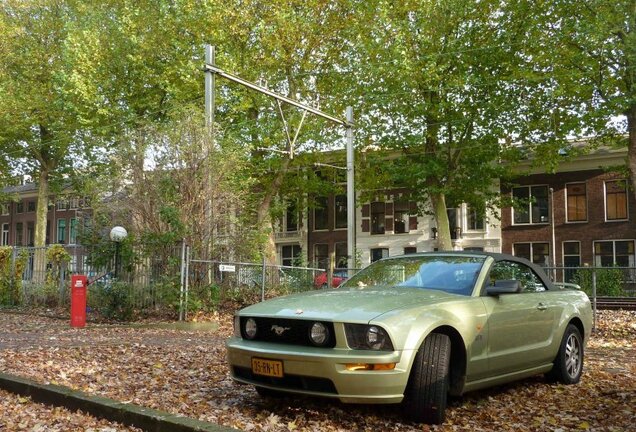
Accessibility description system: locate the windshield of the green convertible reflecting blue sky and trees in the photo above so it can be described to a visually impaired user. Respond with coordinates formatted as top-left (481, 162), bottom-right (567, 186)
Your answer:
top-left (341, 255), bottom-right (485, 295)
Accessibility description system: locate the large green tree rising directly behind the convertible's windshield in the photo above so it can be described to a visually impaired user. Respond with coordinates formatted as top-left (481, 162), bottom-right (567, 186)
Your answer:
top-left (354, 0), bottom-right (520, 250)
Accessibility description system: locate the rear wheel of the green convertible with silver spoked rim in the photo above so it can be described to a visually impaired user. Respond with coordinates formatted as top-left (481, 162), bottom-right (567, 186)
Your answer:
top-left (546, 324), bottom-right (584, 384)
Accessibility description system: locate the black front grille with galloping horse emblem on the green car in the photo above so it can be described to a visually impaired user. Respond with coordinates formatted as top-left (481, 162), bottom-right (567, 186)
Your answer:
top-left (241, 317), bottom-right (336, 348)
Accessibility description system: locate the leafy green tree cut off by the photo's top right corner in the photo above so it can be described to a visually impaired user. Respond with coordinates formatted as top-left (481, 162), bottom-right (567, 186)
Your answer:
top-left (514, 0), bottom-right (636, 192)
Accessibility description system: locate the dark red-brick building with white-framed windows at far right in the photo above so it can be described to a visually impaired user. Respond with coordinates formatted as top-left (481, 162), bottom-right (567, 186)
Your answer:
top-left (501, 145), bottom-right (636, 274)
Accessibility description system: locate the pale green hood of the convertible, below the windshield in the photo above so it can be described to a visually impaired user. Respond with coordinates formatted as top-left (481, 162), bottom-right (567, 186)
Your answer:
top-left (240, 287), bottom-right (464, 322)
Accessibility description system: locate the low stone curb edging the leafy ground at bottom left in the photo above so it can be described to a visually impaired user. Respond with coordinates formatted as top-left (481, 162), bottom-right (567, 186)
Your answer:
top-left (0, 373), bottom-right (238, 432)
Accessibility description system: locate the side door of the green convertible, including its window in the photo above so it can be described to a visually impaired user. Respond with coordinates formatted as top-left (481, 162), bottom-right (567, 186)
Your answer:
top-left (482, 260), bottom-right (556, 375)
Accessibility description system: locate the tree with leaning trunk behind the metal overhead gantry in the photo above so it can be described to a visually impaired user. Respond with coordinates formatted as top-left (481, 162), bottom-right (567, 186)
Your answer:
top-left (217, 0), bottom-right (362, 262)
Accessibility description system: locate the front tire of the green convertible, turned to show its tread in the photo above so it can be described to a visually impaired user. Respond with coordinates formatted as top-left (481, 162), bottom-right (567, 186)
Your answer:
top-left (404, 333), bottom-right (451, 424)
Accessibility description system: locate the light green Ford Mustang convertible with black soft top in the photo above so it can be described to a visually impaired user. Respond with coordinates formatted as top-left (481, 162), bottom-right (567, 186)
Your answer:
top-left (227, 252), bottom-right (592, 423)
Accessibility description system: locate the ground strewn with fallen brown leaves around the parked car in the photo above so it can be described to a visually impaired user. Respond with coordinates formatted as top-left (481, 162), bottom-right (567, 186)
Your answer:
top-left (0, 311), bottom-right (636, 432)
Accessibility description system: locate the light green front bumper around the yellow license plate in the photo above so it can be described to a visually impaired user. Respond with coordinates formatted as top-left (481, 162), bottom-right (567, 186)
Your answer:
top-left (227, 337), bottom-right (416, 403)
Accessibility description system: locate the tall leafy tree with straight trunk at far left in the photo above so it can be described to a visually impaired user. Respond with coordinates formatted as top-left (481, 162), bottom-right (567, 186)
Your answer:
top-left (0, 0), bottom-right (83, 246)
